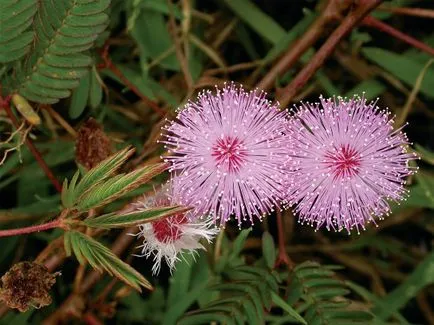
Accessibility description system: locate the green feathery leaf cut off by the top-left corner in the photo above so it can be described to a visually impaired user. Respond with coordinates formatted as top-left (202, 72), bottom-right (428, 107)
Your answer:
top-left (0, 0), bottom-right (37, 63)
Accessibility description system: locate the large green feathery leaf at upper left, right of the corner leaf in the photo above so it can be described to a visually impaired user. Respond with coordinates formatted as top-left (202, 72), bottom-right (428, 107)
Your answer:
top-left (7, 0), bottom-right (110, 102)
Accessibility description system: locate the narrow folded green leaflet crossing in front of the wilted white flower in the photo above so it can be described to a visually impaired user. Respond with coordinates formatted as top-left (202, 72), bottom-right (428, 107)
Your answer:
top-left (83, 206), bottom-right (188, 229)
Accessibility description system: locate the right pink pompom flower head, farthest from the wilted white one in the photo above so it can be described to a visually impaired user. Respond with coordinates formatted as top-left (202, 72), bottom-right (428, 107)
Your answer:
top-left (288, 96), bottom-right (417, 233)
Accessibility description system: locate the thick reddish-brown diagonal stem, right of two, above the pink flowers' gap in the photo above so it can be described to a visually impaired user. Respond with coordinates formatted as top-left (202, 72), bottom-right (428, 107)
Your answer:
top-left (277, 0), bottom-right (382, 107)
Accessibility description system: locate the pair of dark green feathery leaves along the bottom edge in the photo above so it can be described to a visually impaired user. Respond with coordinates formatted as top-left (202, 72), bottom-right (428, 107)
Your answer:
top-left (177, 262), bottom-right (373, 325)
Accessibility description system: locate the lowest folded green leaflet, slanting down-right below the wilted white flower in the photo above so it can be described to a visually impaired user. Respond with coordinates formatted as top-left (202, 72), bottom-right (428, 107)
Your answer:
top-left (64, 231), bottom-right (152, 291)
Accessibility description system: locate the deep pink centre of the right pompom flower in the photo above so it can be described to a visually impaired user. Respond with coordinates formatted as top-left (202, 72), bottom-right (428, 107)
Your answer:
top-left (325, 145), bottom-right (360, 178)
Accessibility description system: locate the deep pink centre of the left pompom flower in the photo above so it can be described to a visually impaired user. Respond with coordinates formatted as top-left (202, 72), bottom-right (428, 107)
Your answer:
top-left (211, 136), bottom-right (247, 173)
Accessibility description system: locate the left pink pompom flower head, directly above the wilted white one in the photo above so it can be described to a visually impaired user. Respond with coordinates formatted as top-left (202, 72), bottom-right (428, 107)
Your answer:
top-left (162, 83), bottom-right (290, 225)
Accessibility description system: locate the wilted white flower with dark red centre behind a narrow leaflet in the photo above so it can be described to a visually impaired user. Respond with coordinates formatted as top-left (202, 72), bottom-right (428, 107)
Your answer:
top-left (134, 183), bottom-right (219, 274)
